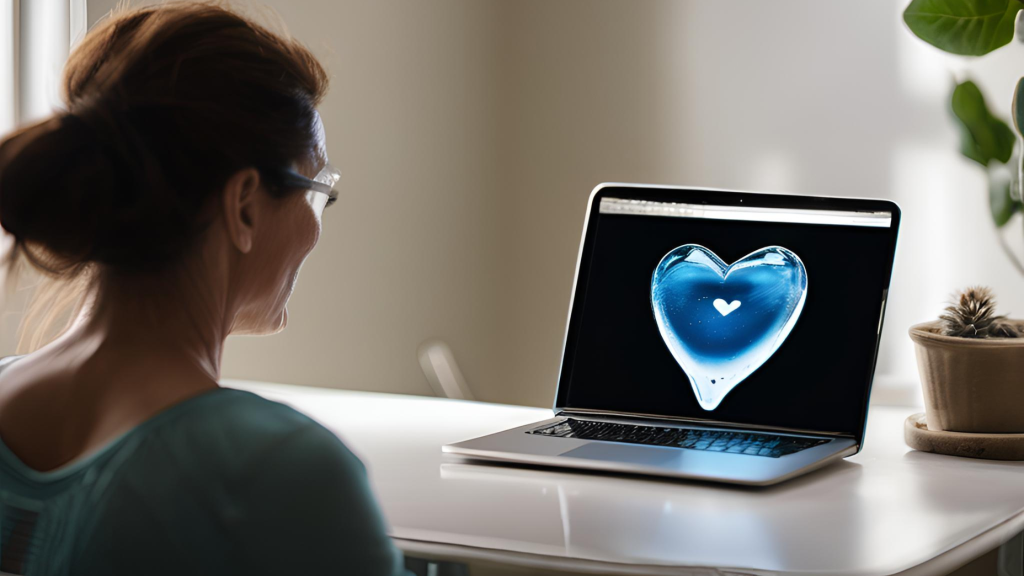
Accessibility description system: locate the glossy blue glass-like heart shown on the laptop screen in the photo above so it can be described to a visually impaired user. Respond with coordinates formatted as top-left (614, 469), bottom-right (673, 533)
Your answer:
top-left (650, 244), bottom-right (807, 411)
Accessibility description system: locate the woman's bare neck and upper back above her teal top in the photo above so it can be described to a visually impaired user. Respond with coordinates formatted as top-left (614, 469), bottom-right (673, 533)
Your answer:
top-left (0, 264), bottom-right (231, 470)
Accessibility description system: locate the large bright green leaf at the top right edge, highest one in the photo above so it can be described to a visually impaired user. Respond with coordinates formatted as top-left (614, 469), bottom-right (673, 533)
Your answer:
top-left (903, 0), bottom-right (1024, 56)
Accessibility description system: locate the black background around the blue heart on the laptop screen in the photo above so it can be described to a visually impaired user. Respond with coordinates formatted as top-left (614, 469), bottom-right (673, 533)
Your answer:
top-left (563, 210), bottom-right (893, 435)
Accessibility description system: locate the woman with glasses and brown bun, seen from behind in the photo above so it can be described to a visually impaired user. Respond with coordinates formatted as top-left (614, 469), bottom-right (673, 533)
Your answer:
top-left (0, 2), bottom-right (402, 576)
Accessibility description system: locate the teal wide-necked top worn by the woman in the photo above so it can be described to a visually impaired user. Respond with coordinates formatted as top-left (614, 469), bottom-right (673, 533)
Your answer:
top-left (0, 359), bottom-right (404, 576)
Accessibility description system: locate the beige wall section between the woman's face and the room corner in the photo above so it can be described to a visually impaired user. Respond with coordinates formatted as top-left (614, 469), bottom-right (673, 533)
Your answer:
top-left (224, 0), bottom-right (497, 398)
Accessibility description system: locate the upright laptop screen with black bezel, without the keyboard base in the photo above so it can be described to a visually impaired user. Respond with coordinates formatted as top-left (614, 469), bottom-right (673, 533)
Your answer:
top-left (557, 190), bottom-right (899, 436)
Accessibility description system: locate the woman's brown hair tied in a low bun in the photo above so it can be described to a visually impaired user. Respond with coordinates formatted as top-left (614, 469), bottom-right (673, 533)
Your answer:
top-left (0, 2), bottom-right (328, 344)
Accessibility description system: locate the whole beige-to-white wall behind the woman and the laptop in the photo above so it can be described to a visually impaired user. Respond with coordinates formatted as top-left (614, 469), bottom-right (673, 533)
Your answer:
top-left (6, 0), bottom-right (1024, 405)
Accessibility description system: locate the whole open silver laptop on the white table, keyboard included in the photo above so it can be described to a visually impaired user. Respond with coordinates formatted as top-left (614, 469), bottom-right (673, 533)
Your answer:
top-left (442, 183), bottom-right (900, 486)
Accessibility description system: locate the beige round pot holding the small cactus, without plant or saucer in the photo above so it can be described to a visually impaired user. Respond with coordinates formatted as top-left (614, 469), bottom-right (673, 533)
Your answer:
top-left (910, 321), bottom-right (1024, 434)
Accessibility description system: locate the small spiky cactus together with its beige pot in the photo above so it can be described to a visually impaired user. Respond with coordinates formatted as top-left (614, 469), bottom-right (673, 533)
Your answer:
top-left (910, 287), bottom-right (1024, 434)
